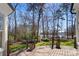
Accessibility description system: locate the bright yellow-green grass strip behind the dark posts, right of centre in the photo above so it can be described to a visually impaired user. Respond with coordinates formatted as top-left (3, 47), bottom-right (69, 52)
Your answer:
top-left (36, 40), bottom-right (74, 46)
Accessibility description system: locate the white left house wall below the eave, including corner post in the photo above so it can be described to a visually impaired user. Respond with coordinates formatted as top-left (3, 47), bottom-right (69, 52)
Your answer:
top-left (0, 12), bottom-right (8, 55)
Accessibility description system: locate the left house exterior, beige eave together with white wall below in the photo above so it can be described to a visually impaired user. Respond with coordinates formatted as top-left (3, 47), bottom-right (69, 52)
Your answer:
top-left (0, 3), bottom-right (13, 56)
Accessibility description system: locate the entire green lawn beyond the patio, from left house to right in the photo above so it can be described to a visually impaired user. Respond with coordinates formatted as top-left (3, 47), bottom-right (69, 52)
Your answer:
top-left (9, 40), bottom-right (74, 53)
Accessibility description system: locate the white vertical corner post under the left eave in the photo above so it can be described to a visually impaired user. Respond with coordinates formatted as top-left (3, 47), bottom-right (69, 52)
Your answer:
top-left (2, 16), bottom-right (8, 56)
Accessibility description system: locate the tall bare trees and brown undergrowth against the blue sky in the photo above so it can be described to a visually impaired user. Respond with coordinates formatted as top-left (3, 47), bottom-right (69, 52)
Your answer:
top-left (9, 3), bottom-right (75, 48)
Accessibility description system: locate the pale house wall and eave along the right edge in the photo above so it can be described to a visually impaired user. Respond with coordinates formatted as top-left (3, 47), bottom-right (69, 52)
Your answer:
top-left (73, 3), bottom-right (79, 49)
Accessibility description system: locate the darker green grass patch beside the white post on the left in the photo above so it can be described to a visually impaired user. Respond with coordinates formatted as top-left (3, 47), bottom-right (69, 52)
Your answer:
top-left (9, 43), bottom-right (26, 53)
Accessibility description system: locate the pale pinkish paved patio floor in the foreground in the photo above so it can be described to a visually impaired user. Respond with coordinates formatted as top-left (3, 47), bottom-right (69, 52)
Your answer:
top-left (11, 46), bottom-right (79, 56)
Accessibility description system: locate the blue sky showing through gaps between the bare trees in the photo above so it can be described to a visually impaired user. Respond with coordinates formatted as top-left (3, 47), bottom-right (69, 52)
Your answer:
top-left (9, 3), bottom-right (74, 31)
